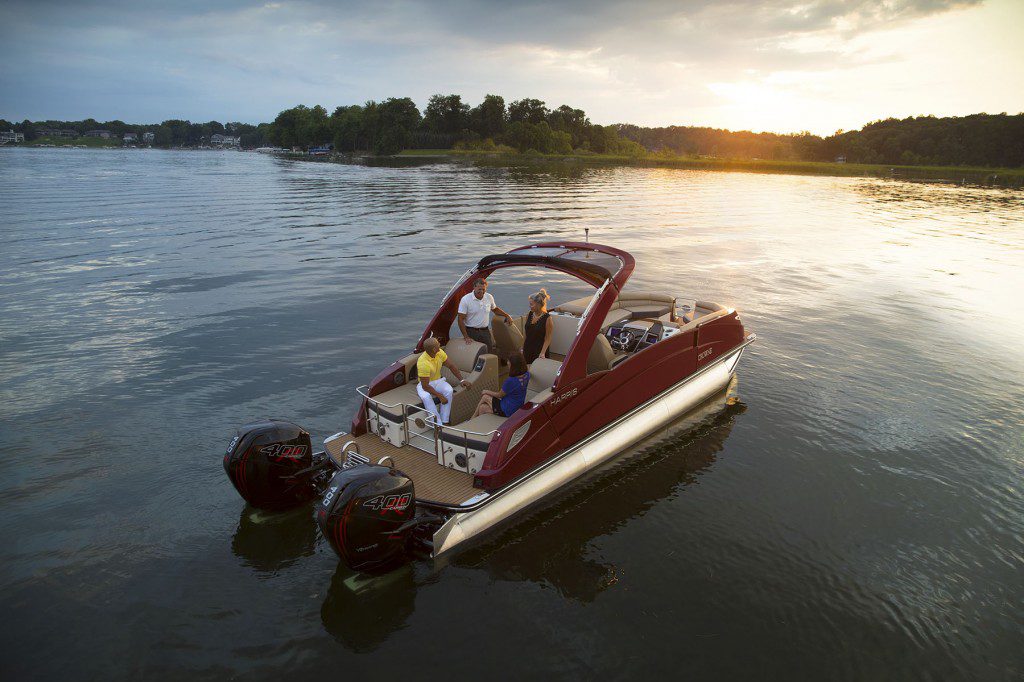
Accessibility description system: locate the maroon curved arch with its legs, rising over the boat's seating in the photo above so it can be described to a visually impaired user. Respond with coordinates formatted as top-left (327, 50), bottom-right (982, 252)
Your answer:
top-left (416, 242), bottom-right (636, 389)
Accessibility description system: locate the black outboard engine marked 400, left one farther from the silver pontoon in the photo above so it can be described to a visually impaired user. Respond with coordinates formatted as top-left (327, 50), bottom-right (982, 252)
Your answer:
top-left (224, 420), bottom-right (327, 509)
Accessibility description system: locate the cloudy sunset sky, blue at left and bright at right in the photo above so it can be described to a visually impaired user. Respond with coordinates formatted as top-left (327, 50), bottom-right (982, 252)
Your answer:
top-left (0, 0), bottom-right (1024, 134)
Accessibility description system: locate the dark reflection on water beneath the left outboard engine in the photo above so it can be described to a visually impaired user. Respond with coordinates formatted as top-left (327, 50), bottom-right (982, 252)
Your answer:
top-left (231, 505), bottom-right (316, 572)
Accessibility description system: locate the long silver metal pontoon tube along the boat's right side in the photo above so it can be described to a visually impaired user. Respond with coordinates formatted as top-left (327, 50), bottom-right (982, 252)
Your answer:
top-left (433, 335), bottom-right (754, 558)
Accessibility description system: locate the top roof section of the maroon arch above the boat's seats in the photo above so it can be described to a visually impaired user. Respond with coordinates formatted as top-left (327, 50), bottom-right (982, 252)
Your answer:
top-left (476, 242), bottom-right (635, 289)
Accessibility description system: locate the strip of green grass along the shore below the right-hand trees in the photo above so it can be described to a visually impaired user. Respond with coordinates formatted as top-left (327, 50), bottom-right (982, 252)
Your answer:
top-left (399, 150), bottom-right (1024, 185)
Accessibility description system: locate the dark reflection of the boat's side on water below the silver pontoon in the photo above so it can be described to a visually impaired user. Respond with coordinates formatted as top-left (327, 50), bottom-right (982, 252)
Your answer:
top-left (453, 379), bottom-right (746, 602)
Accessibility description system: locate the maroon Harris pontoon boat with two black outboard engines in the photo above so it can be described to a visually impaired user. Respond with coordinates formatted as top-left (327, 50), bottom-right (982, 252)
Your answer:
top-left (224, 242), bottom-right (755, 572)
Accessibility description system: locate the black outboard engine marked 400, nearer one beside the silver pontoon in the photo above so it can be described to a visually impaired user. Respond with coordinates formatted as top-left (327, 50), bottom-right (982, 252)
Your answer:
top-left (316, 464), bottom-right (416, 572)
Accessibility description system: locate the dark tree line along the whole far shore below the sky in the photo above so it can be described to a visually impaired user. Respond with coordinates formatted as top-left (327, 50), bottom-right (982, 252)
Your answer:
top-left (0, 94), bottom-right (1024, 168)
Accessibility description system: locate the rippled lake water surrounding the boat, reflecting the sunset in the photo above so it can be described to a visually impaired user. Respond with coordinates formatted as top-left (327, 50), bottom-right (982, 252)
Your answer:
top-left (0, 150), bottom-right (1024, 680)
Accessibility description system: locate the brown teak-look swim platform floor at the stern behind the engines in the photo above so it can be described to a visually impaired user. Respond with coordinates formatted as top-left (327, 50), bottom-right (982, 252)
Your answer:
top-left (325, 433), bottom-right (483, 505)
